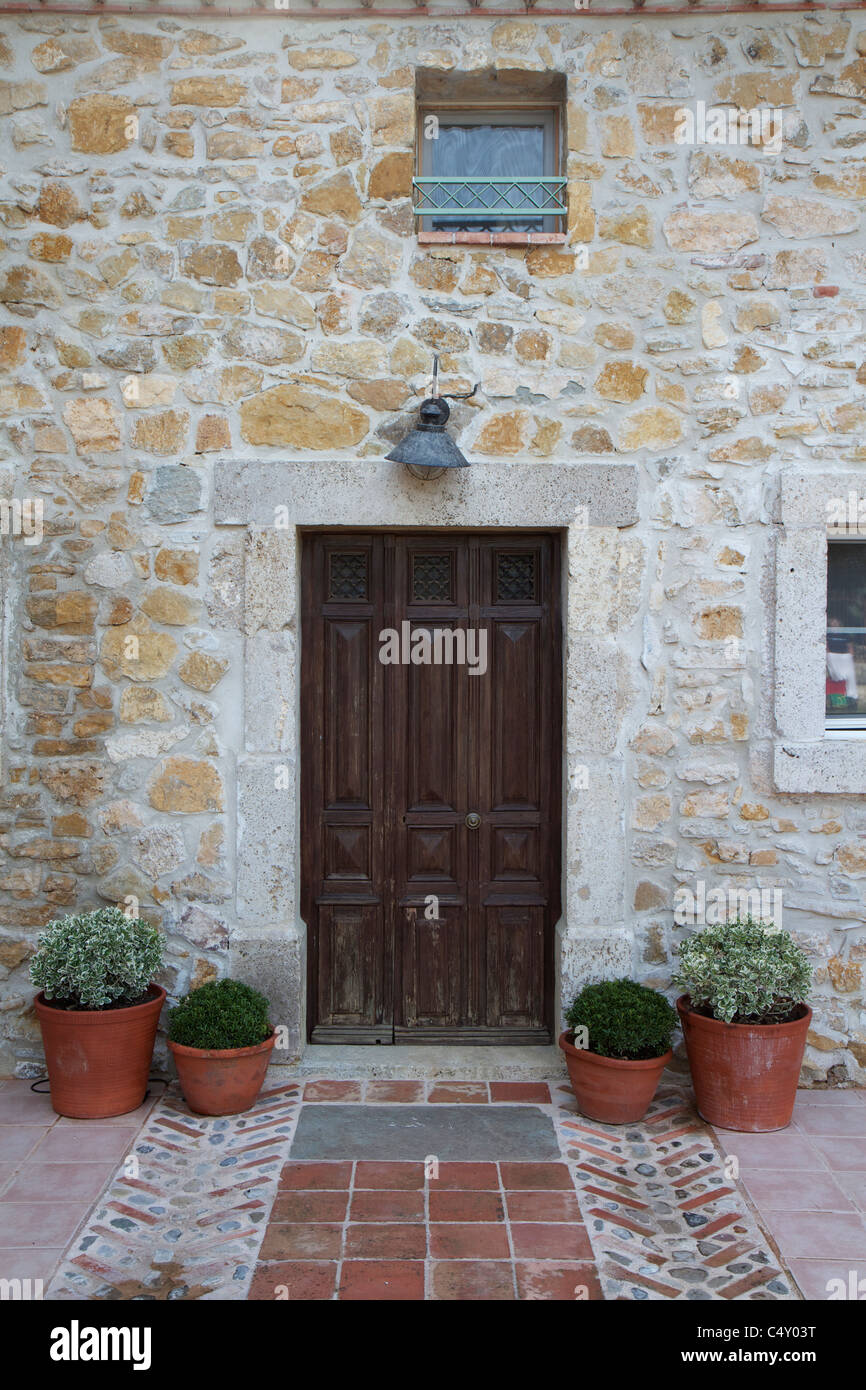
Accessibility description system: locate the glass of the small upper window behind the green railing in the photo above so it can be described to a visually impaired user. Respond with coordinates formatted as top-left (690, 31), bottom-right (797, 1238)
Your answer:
top-left (431, 121), bottom-right (550, 232)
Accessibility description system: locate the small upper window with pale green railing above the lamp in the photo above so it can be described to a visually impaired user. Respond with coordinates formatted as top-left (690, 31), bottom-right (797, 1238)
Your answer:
top-left (414, 104), bottom-right (566, 234)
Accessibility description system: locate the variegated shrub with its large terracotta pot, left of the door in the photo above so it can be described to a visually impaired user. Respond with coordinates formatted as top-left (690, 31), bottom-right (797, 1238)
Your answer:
top-left (31, 908), bottom-right (165, 1119)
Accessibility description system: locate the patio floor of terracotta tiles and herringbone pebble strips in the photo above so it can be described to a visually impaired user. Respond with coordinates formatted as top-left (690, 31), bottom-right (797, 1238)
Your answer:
top-left (0, 1068), bottom-right (866, 1301)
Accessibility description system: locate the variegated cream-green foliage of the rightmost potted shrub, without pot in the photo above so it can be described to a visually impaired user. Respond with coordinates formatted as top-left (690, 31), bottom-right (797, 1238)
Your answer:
top-left (674, 916), bottom-right (812, 1023)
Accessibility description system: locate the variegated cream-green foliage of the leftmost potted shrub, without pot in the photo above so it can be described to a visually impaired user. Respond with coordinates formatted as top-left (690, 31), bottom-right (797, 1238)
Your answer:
top-left (31, 908), bottom-right (165, 1009)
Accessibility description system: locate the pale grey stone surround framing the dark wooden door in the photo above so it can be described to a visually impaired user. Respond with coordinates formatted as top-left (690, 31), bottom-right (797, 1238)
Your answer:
top-left (214, 459), bottom-right (638, 1061)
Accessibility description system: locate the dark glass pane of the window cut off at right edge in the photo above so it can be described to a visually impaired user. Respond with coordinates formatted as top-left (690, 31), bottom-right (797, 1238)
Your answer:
top-left (827, 541), bottom-right (866, 721)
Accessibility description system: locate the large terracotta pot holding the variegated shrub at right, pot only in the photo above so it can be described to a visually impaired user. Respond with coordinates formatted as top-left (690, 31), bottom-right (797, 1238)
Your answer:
top-left (677, 994), bottom-right (812, 1134)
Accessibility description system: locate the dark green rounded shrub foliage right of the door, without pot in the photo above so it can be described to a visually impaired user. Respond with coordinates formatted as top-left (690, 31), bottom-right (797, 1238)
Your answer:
top-left (566, 980), bottom-right (677, 1062)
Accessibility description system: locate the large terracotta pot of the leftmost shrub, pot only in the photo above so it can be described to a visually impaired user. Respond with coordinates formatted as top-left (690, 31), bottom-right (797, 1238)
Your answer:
top-left (33, 984), bottom-right (165, 1120)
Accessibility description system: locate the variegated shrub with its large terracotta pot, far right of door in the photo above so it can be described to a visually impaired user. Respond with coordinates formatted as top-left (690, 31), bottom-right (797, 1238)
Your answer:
top-left (674, 917), bottom-right (812, 1133)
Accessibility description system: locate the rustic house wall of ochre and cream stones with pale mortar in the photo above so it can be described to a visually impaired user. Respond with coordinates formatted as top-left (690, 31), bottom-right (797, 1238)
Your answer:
top-left (0, 14), bottom-right (866, 1084)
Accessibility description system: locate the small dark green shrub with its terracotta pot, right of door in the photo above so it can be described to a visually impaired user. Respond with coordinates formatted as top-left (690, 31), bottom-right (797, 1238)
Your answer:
top-left (559, 980), bottom-right (677, 1125)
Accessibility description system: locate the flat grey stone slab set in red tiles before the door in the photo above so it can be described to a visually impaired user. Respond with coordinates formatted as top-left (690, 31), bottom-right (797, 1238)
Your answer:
top-left (291, 1104), bottom-right (562, 1162)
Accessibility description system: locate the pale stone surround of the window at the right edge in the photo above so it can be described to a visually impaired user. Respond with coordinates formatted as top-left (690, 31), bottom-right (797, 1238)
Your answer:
top-left (773, 473), bottom-right (866, 795)
